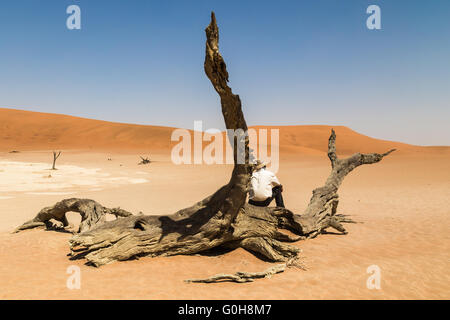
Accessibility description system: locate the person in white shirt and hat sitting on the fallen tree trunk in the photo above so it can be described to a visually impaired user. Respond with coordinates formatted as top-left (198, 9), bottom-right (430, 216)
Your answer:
top-left (248, 160), bottom-right (284, 208)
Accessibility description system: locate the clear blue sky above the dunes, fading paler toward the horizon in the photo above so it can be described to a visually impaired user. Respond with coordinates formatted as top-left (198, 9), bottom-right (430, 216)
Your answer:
top-left (0, 0), bottom-right (450, 145)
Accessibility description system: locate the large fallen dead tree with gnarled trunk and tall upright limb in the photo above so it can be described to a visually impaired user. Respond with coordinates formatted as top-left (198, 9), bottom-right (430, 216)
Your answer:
top-left (14, 13), bottom-right (393, 272)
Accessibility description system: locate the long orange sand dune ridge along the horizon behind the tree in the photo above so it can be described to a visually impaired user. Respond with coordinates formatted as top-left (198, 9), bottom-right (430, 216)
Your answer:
top-left (0, 108), bottom-right (450, 155)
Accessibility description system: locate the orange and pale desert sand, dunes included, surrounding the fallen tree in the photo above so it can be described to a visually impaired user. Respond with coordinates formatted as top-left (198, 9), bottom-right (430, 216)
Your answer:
top-left (0, 109), bottom-right (450, 299)
